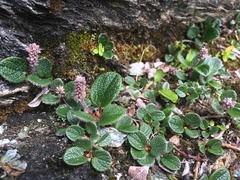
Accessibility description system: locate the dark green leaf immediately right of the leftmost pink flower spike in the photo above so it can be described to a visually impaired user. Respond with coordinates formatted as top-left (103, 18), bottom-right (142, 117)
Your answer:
top-left (36, 58), bottom-right (52, 78)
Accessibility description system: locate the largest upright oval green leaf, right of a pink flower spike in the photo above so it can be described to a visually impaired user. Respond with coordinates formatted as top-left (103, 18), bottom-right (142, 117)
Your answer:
top-left (91, 72), bottom-right (122, 107)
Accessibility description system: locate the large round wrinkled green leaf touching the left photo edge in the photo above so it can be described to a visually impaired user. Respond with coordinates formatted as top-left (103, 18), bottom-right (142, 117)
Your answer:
top-left (0, 56), bottom-right (28, 83)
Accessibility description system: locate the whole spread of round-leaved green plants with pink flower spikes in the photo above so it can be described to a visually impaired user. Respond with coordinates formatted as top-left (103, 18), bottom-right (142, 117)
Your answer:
top-left (0, 15), bottom-right (240, 179)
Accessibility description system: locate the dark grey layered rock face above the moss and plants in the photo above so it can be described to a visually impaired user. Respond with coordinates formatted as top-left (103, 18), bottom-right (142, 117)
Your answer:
top-left (0, 0), bottom-right (240, 103)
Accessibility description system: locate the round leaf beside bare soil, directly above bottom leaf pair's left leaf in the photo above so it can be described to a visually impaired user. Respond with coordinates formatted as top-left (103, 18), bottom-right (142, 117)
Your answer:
top-left (66, 125), bottom-right (85, 141)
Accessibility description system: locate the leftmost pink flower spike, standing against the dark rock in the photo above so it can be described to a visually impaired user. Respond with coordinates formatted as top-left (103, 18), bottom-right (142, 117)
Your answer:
top-left (26, 43), bottom-right (41, 68)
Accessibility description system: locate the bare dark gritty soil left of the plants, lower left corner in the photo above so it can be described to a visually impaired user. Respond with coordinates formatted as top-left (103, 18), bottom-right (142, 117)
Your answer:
top-left (0, 112), bottom-right (106, 180)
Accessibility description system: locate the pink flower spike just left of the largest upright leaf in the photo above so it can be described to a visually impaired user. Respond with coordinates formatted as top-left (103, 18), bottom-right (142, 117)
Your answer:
top-left (74, 76), bottom-right (86, 103)
